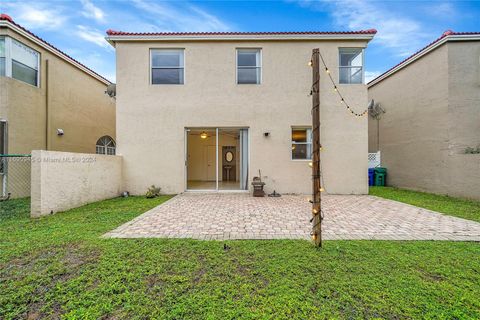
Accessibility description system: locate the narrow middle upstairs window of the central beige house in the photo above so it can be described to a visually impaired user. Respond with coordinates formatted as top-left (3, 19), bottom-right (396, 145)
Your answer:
top-left (237, 49), bottom-right (262, 84)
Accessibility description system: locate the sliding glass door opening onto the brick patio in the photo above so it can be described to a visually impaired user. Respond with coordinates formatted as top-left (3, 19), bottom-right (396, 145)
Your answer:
top-left (185, 128), bottom-right (248, 191)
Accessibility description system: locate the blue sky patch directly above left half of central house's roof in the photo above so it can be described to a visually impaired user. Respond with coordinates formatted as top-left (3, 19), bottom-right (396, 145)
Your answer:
top-left (129, 0), bottom-right (230, 31)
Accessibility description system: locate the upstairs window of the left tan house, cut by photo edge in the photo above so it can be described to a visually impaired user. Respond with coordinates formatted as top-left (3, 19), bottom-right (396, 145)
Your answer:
top-left (0, 37), bottom-right (40, 87)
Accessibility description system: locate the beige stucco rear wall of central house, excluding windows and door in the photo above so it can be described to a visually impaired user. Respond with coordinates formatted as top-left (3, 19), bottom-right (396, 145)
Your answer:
top-left (116, 41), bottom-right (368, 194)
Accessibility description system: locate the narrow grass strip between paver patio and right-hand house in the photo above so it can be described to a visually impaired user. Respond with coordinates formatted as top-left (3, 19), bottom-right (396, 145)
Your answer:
top-left (370, 187), bottom-right (480, 222)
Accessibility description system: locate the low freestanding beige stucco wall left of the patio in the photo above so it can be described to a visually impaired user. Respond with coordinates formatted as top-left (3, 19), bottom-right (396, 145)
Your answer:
top-left (31, 150), bottom-right (122, 217)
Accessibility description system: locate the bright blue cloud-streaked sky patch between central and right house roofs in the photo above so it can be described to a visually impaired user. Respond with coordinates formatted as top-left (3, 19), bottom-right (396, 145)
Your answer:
top-left (301, 0), bottom-right (435, 57)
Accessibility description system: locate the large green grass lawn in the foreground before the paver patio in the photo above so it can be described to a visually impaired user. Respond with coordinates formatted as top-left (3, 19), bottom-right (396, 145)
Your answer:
top-left (0, 197), bottom-right (480, 319)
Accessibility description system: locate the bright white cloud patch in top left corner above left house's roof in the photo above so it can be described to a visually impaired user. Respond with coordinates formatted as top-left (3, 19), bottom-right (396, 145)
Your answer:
top-left (5, 3), bottom-right (67, 30)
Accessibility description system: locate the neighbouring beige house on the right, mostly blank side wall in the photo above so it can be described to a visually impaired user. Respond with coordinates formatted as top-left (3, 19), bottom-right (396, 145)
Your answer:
top-left (368, 31), bottom-right (480, 199)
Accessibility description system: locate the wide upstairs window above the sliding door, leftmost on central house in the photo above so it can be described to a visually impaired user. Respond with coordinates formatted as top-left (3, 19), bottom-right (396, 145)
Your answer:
top-left (151, 49), bottom-right (185, 84)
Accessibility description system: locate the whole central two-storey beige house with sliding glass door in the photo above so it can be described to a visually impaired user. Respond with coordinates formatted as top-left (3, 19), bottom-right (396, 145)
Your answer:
top-left (107, 30), bottom-right (376, 194)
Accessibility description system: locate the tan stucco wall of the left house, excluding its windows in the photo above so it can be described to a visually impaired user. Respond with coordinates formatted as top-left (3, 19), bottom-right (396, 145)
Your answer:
top-left (0, 28), bottom-right (116, 154)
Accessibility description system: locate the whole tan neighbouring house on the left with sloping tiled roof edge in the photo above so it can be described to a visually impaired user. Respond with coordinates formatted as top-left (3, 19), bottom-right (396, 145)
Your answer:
top-left (0, 14), bottom-right (115, 196)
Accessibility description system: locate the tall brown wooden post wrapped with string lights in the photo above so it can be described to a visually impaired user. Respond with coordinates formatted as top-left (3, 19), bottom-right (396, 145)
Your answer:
top-left (311, 49), bottom-right (322, 247)
